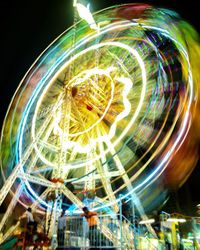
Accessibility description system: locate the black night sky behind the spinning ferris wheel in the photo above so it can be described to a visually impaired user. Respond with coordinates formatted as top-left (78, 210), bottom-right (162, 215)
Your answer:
top-left (0, 0), bottom-right (200, 213)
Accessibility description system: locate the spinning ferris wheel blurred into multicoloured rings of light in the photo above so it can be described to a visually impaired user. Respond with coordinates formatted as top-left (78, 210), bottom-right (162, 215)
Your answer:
top-left (0, 0), bottom-right (199, 243)
